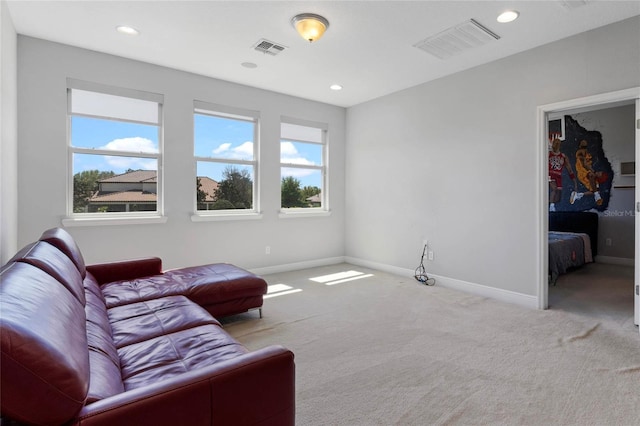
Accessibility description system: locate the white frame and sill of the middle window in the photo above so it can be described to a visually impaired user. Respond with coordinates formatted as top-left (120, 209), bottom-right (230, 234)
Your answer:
top-left (191, 100), bottom-right (262, 222)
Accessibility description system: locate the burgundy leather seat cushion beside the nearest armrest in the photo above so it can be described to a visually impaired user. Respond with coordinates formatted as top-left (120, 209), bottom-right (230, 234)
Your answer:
top-left (118, 324), bottom-right (248, 390)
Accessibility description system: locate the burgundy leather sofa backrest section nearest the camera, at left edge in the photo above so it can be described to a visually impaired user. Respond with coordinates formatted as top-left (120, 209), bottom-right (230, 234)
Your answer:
top-left (0, 261), bottom-right (90, 424)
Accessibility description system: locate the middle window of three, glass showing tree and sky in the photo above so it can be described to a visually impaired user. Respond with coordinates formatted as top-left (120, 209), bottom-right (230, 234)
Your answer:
top-left (194, 101), bottom-right (258, 214)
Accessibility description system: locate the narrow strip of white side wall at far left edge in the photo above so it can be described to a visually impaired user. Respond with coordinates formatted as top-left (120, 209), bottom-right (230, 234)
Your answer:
top-left (0, 0), bottom-right (18, 264)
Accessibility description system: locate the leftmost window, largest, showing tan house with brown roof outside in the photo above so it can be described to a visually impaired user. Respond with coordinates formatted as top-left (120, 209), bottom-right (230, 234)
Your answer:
top-left (68, 82), bottom-right (162, 217)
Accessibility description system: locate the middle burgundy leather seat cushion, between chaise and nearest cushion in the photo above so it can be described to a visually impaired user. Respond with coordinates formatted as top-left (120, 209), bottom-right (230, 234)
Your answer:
top-left (108, 296), bottom-right (220, 348)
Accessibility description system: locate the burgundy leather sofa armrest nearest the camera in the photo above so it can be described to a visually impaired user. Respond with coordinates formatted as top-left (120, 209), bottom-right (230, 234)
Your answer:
top-left (73, 346), bottom-right (295, 426)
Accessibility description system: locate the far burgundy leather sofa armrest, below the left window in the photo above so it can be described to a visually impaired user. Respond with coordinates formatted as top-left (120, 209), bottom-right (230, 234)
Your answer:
top-left (87, 257), bottom-right (162, 285)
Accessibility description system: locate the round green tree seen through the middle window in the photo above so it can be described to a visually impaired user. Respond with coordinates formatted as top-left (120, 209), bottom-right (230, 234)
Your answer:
top-left (213, 166), bottom-right (253, 210)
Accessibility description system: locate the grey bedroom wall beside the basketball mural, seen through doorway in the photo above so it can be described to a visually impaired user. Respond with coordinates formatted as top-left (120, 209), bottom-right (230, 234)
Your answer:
top-left (567, 105), bottom-right (640, 260)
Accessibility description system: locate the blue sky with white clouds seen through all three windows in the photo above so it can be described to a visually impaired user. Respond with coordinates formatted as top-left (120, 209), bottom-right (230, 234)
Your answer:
top-left (71, 114), bottom-right (322, 187)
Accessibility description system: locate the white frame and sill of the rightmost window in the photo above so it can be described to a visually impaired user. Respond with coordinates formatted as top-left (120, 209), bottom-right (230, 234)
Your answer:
top-left (278, 116), bottom-right (331, 219)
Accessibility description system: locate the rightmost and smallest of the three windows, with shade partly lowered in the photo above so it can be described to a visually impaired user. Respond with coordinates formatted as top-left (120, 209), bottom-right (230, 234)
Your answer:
top-left (280, 119), bottom-right (328, 212)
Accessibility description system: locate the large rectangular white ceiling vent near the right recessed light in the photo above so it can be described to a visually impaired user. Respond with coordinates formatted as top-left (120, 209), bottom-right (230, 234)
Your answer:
top-left (414, 19), bottom-right (500, 59)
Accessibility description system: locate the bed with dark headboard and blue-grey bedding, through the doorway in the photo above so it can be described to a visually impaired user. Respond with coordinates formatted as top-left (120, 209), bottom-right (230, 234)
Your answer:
top-left (549, 212), bottom-right (598, 285)
